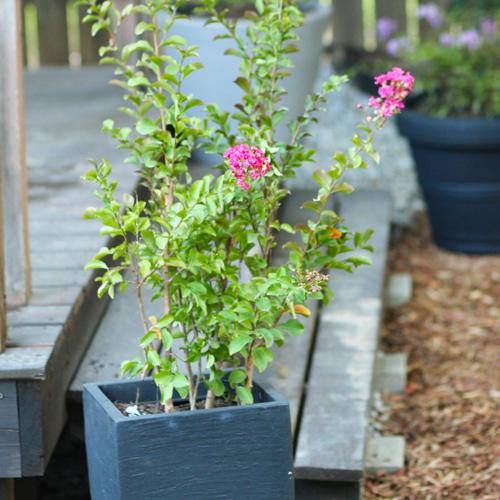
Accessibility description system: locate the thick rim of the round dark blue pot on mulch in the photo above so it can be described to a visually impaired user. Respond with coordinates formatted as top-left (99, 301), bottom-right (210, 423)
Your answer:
top-left (396, 107), bottom-right (500, 149)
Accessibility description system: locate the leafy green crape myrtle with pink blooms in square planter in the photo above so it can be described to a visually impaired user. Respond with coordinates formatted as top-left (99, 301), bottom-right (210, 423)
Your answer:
top-left (79, 0), bottom-right (412, 412)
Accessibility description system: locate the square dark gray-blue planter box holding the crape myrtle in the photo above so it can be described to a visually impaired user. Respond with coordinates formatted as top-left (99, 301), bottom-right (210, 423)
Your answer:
top-left (83, 379), bottom-right (294, 500)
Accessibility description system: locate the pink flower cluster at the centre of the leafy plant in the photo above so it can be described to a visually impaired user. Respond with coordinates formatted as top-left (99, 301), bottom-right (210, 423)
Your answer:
top-left (224, 144), bottom-right (271, 191)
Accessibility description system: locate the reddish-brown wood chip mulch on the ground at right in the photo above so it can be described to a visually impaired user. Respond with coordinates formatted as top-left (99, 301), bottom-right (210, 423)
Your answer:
top-left (365, 216), bottom-right (500, 500)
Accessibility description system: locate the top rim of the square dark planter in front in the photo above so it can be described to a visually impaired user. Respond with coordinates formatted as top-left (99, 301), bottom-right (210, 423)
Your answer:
top-left (83, 374), bottom-right (288, 423)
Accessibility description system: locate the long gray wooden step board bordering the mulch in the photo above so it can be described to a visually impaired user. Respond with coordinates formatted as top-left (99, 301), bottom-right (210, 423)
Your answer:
top-left (295, 192), bottom-right (390, 482)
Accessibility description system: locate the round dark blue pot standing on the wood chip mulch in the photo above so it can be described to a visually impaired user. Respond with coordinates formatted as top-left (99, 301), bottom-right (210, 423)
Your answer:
top-left (397, 109), bottom-right (500, 253)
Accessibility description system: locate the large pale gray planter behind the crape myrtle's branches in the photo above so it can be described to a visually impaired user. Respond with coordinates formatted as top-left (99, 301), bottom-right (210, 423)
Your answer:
top-left (159, 3), bottom-right (333, 145)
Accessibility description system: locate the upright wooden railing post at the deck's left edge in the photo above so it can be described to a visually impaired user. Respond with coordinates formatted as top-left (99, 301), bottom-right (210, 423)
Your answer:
top-left (0, 0), bottom-right (31, 306)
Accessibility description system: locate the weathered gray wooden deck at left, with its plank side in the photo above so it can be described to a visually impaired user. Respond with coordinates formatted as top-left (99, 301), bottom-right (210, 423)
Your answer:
top-left (0, 67), bottom-right (137, 477)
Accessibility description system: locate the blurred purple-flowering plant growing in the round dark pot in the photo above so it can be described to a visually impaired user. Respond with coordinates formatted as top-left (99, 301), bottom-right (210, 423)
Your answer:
top-left (360, 1), bottom-right (500, 117)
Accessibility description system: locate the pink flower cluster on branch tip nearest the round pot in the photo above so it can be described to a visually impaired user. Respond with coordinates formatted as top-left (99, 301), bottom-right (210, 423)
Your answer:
top-left (368, 68), bottom-right (415, 117)
